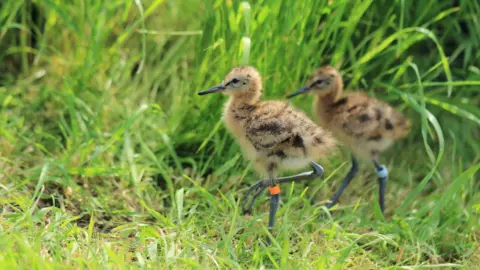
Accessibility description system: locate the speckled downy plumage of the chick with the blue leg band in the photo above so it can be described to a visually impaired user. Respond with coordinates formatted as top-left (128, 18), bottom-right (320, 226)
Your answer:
top-left (309, 66), bottom-right (411, 159)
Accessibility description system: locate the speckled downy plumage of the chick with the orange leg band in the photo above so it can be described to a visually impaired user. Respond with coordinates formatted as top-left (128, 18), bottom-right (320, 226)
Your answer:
top-left (223, 67), bottom-right (335, 177)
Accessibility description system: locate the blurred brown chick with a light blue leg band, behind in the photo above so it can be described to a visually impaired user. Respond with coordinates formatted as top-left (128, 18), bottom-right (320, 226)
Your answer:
top-left (288, 66), bottom-right (411, 213)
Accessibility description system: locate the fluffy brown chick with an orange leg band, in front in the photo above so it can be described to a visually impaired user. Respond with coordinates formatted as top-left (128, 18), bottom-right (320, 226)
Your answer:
top-left (198, 66), bottom-right (335, 242)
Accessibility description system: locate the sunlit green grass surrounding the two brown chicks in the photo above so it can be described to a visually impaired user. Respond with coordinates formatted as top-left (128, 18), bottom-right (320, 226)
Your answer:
top-left (0, 0), bottom-right (480, 269)
